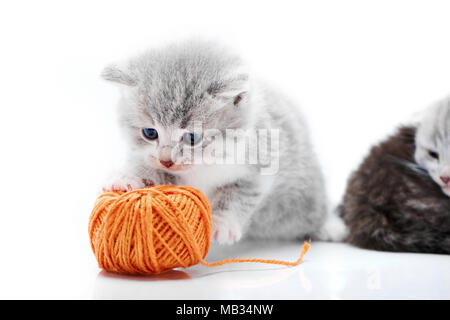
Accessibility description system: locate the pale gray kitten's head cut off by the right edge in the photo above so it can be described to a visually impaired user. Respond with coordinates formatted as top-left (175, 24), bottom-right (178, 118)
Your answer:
top-left (415, 99), bottom-right (450, 196)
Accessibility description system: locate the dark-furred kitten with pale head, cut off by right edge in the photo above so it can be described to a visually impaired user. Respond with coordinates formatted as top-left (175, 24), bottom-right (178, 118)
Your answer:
top-left (340, 100), bottom-right (450, 254)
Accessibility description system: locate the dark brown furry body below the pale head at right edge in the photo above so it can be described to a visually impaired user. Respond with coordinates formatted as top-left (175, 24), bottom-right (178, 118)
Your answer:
top-left (340, 127), bottom-right (450, 254)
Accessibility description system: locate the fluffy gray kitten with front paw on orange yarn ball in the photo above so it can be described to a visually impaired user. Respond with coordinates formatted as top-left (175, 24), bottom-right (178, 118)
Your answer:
top-left (102, 41), bottom-right (345, 244)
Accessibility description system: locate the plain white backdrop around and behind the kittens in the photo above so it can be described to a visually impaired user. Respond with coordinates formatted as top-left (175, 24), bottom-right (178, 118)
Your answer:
top-left (0, 0), bottom-right (450, 298)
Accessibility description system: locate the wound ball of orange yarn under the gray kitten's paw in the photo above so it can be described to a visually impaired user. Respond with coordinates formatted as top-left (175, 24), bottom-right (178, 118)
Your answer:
top-left (89, 185), bottom-right (212, 274)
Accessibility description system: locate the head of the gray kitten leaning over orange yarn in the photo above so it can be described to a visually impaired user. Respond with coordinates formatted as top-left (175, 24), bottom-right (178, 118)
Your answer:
top-left (102, 41), bottom-right (250, 172)
